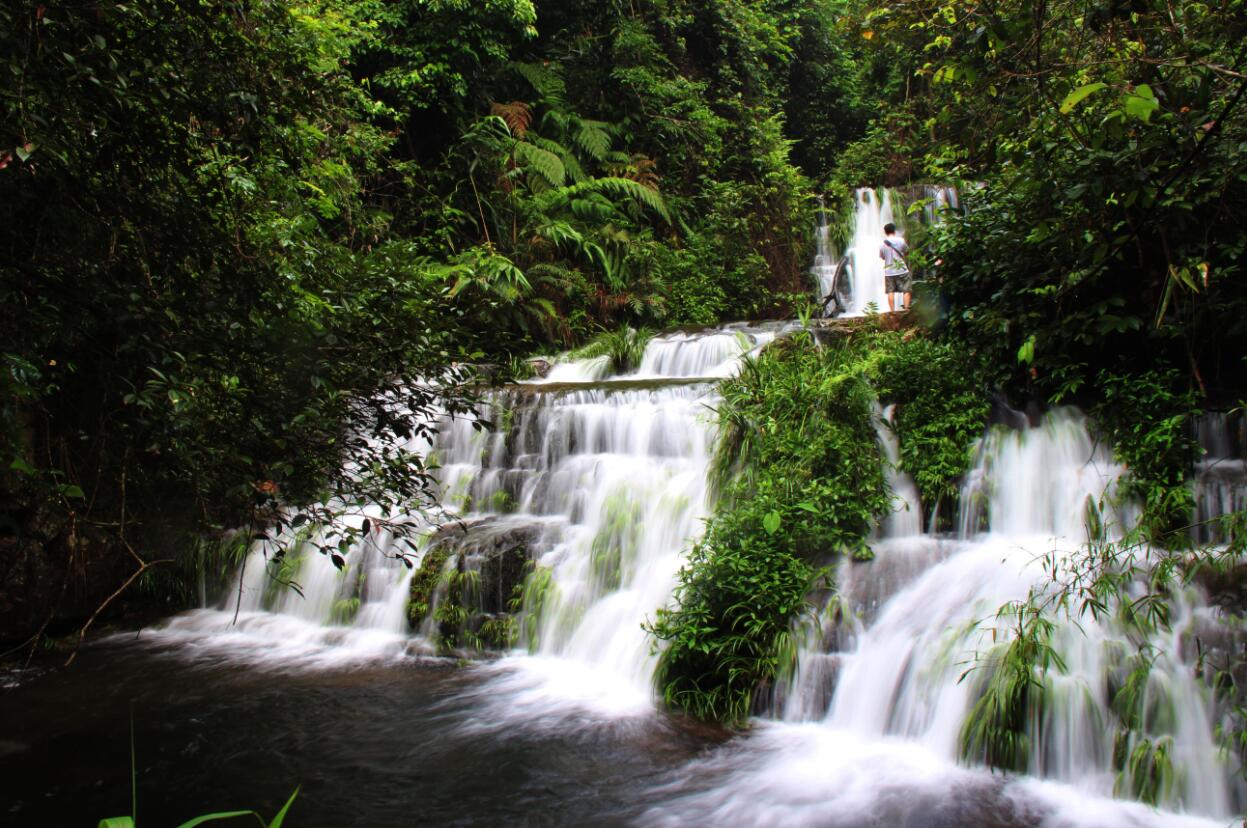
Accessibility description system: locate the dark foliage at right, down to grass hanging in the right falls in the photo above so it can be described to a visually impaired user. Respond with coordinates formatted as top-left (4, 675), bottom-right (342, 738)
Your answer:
top-left (847, 0), bottom-right (1247, 783)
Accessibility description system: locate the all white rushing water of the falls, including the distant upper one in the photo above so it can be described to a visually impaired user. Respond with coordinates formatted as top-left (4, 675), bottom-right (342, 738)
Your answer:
top-left (139, 188), bottom-right (1247, 828)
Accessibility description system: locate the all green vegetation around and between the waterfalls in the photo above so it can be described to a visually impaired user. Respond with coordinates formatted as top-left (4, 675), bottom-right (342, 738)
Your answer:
top-left (0, 0), bottom-right (1247, 799)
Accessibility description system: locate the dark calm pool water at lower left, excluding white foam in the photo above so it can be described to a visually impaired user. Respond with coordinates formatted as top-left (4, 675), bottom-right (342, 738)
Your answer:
top-left (0, 630), bottom-right (715, 827)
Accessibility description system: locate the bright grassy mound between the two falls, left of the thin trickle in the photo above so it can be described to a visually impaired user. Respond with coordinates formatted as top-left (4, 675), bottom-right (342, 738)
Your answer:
top-left (648, 333), bottom-right (912, 723)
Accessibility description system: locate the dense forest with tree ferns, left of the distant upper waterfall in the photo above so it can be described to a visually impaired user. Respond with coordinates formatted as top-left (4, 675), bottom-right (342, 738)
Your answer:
top-left (0, 0), bottom-right (865, 648)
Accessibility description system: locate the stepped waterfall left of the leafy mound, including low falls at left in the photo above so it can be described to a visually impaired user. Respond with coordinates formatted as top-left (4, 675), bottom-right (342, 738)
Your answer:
top-left (150, 323), bottom-right (786, 693)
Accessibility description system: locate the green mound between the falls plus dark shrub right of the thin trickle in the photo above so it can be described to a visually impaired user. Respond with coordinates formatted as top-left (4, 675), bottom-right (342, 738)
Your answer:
top-left (648, 325), bottom-right (988, 723)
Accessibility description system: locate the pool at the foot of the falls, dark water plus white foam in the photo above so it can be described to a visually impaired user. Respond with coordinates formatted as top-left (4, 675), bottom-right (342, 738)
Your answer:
top-left (0, 619), bottom-right (1237, 828)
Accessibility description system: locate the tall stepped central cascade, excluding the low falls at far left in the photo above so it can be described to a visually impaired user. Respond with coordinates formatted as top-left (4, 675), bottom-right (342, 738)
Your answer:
top-left (423, 324), bottom-right (782, 710)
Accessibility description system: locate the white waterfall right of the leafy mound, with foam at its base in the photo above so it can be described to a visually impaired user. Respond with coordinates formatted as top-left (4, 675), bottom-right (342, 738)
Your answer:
top-left (647, 412), bottom-right (1245, 826)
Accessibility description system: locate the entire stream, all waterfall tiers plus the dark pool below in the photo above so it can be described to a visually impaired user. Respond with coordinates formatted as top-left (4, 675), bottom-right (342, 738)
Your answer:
top-left (0, 191), bottom-right (1247, 828)
